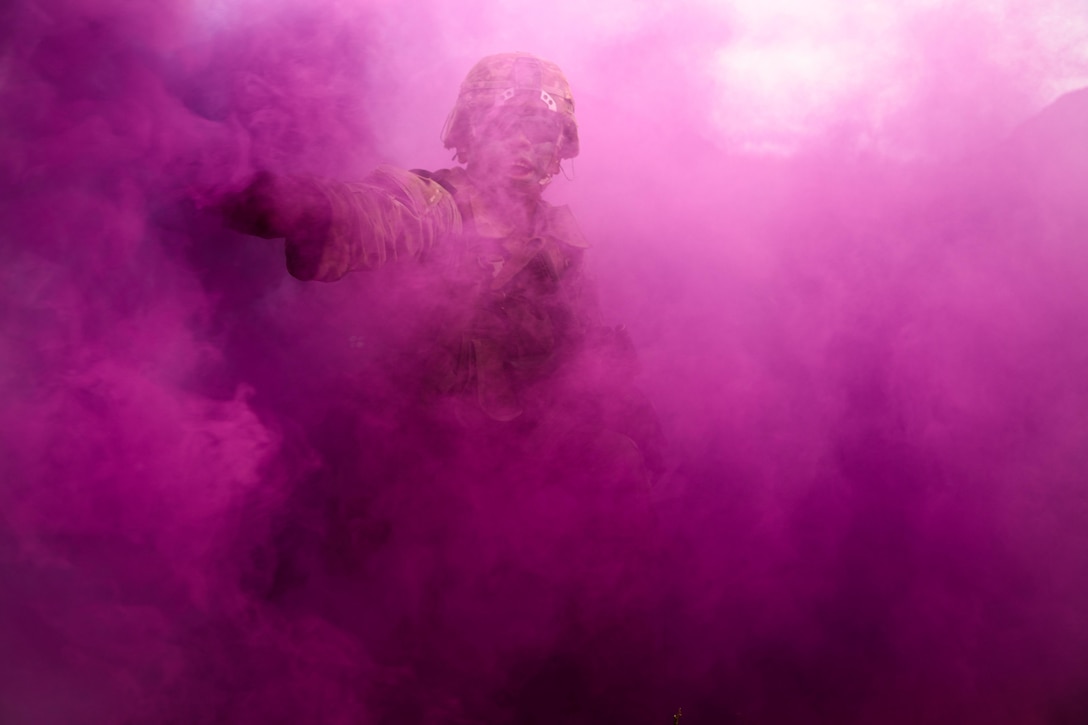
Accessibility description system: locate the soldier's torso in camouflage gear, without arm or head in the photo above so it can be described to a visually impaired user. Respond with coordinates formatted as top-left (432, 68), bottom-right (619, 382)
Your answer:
top-left (422, 169), bottom-right (595, 420)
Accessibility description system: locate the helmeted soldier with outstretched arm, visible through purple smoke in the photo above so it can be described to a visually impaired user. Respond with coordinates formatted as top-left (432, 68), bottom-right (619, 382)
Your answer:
top-left (224, 52), bottom-right (659, 469)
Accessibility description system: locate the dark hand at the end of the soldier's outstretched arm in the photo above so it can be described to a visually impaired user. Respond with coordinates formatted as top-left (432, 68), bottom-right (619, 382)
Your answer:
top-left (218, 171), bottom-right (332, 239)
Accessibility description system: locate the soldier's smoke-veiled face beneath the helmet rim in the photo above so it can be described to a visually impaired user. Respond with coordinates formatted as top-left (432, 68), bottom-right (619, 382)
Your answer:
top-left (469, 106), bottom-right (562, 194)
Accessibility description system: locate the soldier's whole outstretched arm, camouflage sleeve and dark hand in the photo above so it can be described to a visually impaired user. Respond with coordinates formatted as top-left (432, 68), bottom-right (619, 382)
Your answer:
top-left (220, 167), bottom-right (461, 282)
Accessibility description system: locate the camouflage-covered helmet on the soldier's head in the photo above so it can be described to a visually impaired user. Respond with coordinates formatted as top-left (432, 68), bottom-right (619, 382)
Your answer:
top-left (442, 52), bottom-right (578, 159)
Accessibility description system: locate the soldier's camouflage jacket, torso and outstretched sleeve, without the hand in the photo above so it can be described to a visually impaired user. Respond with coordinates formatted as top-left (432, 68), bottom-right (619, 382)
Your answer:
top-left (287, 167), bottom-right (602, 420)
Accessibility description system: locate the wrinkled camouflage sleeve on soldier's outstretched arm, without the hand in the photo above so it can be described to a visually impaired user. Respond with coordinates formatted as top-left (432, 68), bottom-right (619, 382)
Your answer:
top-left (287, 167), bottom-right (461, 282)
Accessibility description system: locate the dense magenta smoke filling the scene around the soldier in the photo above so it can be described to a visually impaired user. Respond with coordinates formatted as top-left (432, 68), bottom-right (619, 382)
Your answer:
top-left (6, 0), bottom-right (1088, 725)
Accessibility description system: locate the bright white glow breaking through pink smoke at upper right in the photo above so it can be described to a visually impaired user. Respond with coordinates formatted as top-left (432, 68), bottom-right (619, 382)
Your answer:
top-left (687, 0), bottom-right (1088, 152)
